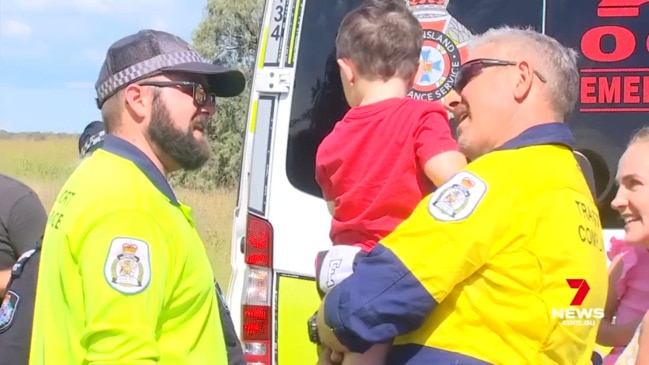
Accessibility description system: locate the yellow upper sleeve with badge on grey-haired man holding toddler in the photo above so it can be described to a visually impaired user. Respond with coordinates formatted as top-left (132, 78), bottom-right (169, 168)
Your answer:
top-left (381, 171), bottom-right (525, 303)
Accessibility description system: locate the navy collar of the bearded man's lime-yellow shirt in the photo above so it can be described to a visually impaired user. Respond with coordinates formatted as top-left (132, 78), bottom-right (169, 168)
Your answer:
top-left (102, 134), bottom-right (179, 205)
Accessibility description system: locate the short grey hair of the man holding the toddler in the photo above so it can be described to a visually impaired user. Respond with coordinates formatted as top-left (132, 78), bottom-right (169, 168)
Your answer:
top-left (469, 26), bottom-right (579, 120)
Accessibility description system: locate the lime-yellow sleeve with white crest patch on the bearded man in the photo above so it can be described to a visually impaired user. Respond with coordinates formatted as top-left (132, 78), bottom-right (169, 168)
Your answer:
top-left (77, 211), bottom-right (170, 365)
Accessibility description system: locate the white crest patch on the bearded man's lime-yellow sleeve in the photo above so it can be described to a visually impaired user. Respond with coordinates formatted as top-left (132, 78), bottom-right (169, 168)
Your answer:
top-left (104, 237), bottom-right (151, 294)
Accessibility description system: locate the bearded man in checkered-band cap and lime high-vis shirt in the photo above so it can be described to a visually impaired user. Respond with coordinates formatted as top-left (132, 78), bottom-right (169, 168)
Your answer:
top-left (29, 30), bottom-right (245, 365)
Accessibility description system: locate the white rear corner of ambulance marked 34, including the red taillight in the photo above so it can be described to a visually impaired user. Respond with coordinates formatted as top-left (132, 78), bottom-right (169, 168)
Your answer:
top-left (227, 0), bottom-right (300, 358)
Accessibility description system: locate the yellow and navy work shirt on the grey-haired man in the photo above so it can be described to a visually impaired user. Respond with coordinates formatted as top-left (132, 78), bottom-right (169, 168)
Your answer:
top-left (324, 123), bottom-right (607, 365)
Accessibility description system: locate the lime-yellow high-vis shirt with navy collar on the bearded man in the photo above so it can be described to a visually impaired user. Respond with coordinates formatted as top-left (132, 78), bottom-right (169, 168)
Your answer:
top-left (29, 136), bottom-right (228, 365)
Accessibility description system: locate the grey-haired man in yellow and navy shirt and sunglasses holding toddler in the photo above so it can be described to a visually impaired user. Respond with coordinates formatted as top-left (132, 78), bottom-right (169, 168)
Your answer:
top-left (315, 27), bottom-right (607, 365)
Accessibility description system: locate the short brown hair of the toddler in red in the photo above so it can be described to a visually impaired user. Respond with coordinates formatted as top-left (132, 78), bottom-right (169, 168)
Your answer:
top-left (336, 0), bottom-right (423, 80)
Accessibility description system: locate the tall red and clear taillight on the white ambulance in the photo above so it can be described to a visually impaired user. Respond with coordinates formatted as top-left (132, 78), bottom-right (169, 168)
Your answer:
top-left (241, 214), bottom-right (273, 365)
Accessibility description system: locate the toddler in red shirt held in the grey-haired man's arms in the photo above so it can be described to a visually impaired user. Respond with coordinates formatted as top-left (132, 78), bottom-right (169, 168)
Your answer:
top-left (316, 0), bottom-right (466, 365)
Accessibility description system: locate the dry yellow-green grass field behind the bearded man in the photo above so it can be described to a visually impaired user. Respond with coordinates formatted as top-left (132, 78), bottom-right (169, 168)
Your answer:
top-left (0, 135), bottom-right (236, 290)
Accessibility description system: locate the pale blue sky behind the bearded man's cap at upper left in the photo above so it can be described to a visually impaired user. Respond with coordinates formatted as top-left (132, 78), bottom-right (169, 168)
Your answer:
top-left (0, 0), bottom-right (206, 133)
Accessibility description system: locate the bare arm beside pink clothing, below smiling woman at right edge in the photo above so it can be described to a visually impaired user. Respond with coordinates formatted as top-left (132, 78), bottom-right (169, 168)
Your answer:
top-left (597, 255), bottom-right (640, 347)
